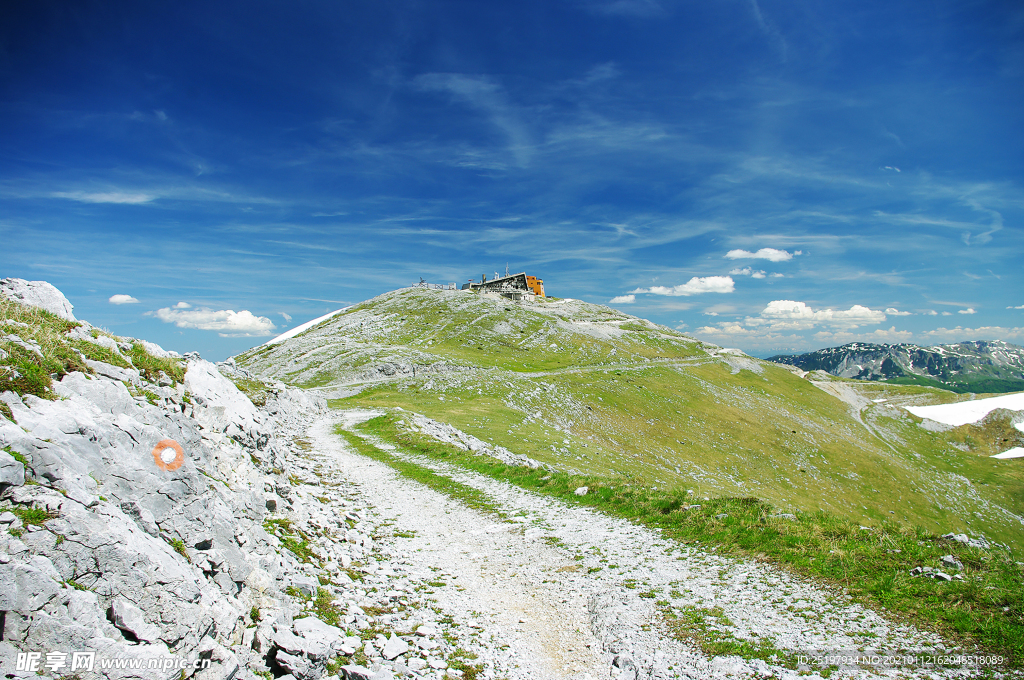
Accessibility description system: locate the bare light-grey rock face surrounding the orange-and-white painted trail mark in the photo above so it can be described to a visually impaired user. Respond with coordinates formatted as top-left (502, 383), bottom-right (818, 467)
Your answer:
top-left (0, 350), bottom-right (326, 680)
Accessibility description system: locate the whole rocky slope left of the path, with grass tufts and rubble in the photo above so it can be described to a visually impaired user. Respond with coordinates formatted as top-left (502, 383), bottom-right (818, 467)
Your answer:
top-left (0, 280), bottom-right (520, 680)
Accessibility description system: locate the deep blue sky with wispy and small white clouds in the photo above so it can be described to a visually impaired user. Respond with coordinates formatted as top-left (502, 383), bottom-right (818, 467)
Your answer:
top-left (0, 0), bottom-right (1024, 359)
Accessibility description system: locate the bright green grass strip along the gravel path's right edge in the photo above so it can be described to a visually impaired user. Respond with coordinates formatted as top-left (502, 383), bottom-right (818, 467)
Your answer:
top-left (346, 415), bottom-right (1024, 668)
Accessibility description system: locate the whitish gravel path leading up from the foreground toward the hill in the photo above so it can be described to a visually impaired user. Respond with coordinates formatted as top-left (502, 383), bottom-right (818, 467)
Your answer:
top-left (309, 411), bottom-right (959, 680)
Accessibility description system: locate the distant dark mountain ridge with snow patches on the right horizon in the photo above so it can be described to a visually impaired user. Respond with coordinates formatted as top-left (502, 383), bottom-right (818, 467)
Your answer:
top-left (768, 340), bottom-right (1024, 392)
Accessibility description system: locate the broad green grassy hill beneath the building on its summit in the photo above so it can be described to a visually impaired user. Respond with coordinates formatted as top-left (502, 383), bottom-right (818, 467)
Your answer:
top-left (237, 289), bottom-right (1024, 548)
